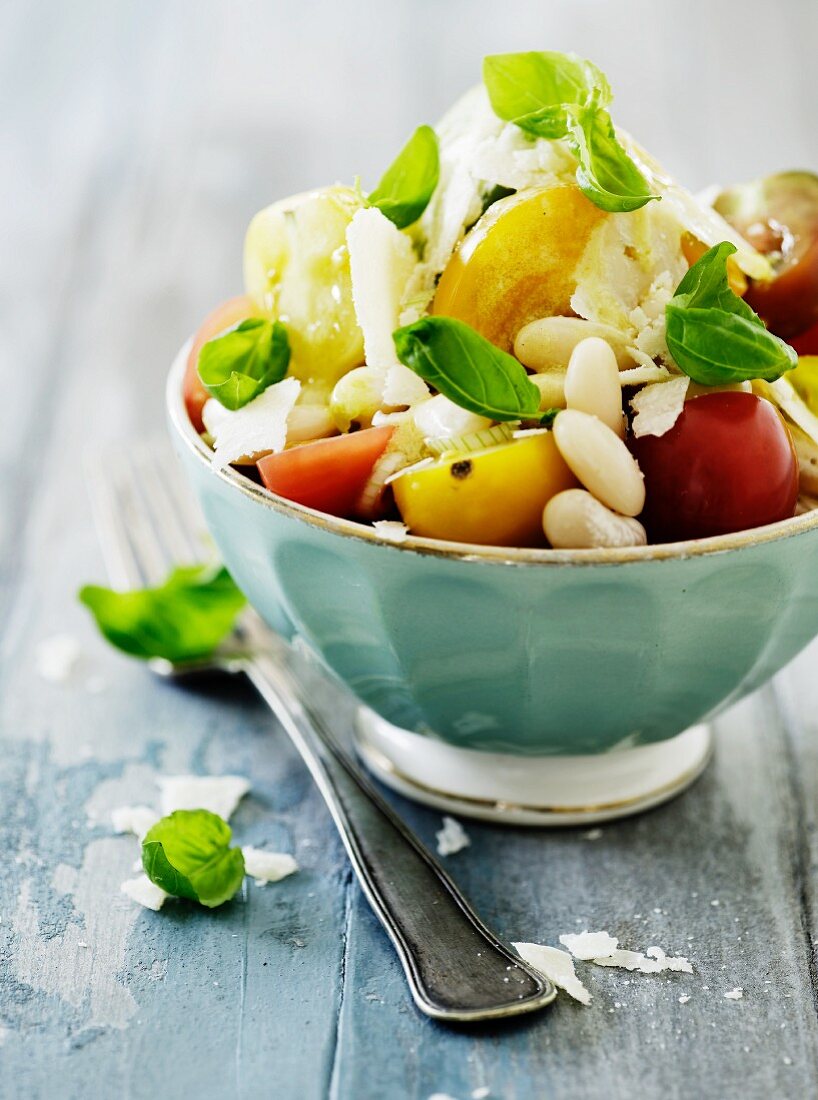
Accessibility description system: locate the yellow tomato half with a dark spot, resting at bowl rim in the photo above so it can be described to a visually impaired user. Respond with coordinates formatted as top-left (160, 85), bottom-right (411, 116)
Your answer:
top-left (393, 431), bottom-right (577, 547)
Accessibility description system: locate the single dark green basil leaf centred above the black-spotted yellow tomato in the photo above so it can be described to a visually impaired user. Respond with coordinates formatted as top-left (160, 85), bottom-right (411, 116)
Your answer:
top-left (393, 317), bottom-right (540, 420)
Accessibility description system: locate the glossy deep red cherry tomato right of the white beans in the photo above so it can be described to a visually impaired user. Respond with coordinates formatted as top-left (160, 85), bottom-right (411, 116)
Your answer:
top-left (630, 393), bottom-right (798, 542)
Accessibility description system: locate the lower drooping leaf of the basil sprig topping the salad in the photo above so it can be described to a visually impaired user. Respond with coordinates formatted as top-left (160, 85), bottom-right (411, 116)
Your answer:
top-left (568, 107), bottom-right (659, 213)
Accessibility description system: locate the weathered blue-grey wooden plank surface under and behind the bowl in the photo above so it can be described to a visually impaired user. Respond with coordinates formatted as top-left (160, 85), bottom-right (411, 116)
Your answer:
top-left (0, 0), bottom-right (818, 1100)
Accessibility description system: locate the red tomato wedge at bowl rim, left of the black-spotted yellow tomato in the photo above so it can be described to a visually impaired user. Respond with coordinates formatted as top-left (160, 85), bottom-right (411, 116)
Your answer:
top-left (256, 425), bottom-right (395, 516)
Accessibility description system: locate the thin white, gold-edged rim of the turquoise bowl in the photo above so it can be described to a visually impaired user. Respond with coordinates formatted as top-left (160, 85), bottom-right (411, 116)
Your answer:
top-left (165, 338), bottom-right (818, 567)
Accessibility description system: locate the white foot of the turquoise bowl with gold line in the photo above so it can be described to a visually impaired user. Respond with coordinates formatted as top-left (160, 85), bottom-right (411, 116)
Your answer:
top-left (356, 707), bottom-right (712, 825)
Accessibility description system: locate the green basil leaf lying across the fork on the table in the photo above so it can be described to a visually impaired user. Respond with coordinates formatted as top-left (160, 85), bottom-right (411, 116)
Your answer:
top-left (79, 565), bottom-right (245, 662)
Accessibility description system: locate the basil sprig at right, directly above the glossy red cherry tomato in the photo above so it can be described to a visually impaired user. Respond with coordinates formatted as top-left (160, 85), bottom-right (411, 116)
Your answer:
top-left (665, 241), bottom-right (798, 386)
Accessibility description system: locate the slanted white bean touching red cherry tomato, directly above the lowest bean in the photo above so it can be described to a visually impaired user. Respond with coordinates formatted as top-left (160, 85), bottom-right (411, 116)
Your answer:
top-left (554, 409), bottom-right (644, 516)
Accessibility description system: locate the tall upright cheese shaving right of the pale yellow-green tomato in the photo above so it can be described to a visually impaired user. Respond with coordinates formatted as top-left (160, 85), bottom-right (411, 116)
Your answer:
top-left (346, 207), bottom-right (417, 367)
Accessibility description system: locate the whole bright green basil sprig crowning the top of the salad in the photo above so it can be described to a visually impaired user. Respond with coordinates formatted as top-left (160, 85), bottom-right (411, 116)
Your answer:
top-left (483, 52), bottom-right (659, 212)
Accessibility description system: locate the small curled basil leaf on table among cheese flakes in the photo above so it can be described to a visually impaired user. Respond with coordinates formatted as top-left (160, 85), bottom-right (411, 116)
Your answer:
top-left (142, 810), bottom-right (244, 909)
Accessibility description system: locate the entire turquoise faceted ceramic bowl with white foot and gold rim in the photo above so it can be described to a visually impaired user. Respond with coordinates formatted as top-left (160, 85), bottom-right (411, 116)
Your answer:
top-left (167, 354), bottom-right (818, 823)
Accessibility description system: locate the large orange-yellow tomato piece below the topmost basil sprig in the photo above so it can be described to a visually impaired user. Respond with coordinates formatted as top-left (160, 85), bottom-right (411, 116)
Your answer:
top-left (432, 184), bottom-right (608, 351)
